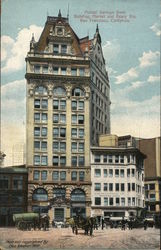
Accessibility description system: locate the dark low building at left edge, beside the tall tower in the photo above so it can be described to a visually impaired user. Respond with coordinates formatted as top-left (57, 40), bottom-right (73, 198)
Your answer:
top-left (0, 165), bottom-right (28, 226)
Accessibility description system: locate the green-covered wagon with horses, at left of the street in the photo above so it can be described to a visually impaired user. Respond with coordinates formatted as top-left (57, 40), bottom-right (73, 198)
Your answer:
top-left (13, 213), bottom-right (49, 230)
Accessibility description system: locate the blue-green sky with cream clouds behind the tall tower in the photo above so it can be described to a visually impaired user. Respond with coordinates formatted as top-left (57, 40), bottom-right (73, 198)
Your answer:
top-left (1, 0), bottom-right (161, 166)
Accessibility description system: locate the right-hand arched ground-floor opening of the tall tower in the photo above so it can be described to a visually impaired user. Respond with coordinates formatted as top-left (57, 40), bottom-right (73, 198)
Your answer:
top-left (71, 188), bottom-right (86, 217)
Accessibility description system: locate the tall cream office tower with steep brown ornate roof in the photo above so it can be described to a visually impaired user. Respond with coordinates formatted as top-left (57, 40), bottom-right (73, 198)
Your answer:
top-left (26, 11), bottom-right (110, 221)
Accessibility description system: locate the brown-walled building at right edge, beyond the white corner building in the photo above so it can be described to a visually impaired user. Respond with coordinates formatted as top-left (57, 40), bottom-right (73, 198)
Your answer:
top-left (138, 137), bottom-right (161, 215)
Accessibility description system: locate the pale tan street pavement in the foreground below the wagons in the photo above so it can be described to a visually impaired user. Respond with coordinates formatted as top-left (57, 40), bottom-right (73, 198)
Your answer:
top-left (0, 228), bottom-right (160, 250)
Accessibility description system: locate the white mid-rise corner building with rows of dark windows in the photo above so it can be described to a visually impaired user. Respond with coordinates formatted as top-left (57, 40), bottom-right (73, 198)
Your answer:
top-left (91, 135), bottom-right (145, 221)
